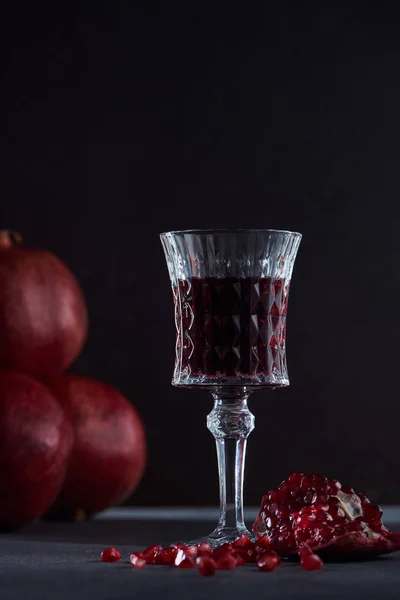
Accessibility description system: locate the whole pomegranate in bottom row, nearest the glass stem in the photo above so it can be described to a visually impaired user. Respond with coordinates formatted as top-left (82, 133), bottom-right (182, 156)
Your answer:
top-left (49, 375), bottom-right (146, 518)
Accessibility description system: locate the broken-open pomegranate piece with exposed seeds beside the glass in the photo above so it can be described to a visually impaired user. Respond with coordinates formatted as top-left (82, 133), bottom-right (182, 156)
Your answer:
top-left (253, 473), bottom-right (400, 564)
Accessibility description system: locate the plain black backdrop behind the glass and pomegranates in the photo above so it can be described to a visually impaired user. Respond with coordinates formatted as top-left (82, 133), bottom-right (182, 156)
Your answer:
top-left (0, 0), bottom-right (400, 505)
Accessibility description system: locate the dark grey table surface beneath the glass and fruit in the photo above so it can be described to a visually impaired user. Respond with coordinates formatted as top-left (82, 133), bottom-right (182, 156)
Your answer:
top-left (0, 508), bottom-right (400, 600)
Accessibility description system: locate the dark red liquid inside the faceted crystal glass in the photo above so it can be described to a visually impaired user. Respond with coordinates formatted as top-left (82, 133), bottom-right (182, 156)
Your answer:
top-left (174, 277), bottom-right (289, 387)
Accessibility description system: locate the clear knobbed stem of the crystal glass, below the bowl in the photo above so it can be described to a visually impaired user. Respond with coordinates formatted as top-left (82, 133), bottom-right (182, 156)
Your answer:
top-left (207, 388), bottom-right (254, 541)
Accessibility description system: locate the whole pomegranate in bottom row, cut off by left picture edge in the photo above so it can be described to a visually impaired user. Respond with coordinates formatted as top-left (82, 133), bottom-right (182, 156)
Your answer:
top-left (0, 372), bottom-right (73, 530)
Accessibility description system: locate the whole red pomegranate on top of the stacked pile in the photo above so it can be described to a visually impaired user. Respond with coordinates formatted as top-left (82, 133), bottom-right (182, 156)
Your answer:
top-left (0, 231), bottom-right (88, 380)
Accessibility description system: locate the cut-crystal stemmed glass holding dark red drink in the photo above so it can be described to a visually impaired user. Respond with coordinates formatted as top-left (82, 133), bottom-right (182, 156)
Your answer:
top-left (160, 229), bottom-right (301, 547)
